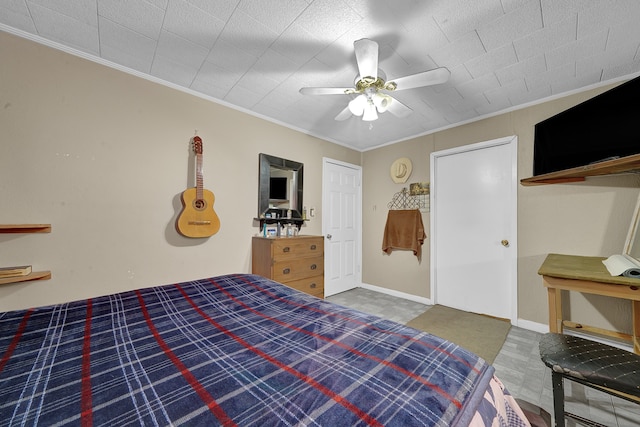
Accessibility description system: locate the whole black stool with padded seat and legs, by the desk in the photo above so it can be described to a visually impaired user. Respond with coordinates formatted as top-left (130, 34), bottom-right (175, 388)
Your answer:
top-left (539, 333), bottom-right (640, 427)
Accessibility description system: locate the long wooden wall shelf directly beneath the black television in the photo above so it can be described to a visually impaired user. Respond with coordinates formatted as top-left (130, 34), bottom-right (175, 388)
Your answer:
top-left (520, 154), bottom-right (640, 186)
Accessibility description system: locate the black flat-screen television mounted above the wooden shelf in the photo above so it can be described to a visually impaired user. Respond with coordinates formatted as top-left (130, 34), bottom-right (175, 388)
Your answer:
top-left (533, 77), bottom-right (640, 175)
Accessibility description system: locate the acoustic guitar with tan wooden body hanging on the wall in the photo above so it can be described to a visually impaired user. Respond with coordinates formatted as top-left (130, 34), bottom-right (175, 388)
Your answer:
top-left (176, 136), bottom-right (220, 238)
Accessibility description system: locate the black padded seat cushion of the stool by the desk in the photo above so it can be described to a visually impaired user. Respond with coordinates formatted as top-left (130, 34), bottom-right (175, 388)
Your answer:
top-left (539, 333), bottom-right (640, 397)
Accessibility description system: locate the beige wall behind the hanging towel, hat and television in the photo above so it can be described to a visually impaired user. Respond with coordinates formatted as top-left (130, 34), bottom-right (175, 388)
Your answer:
top-left (362, 86), bottom-right (640, 332)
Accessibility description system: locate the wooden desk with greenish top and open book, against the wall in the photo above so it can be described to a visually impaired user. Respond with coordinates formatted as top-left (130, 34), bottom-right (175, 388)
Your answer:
top-left (538, 254), bottom-right (640, 354)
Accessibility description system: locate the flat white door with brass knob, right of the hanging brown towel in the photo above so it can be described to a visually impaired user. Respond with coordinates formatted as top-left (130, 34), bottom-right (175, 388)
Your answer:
top-left (431, 136), bottom-right (518, 323)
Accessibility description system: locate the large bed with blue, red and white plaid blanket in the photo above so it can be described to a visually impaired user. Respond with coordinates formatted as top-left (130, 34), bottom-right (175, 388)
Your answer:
top-left (0, 274), bottom-right (529, 426)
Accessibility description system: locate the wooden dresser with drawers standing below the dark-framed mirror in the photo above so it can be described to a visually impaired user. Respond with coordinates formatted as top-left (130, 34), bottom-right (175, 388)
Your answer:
top-left (251, 236), bottom-right (324, 298)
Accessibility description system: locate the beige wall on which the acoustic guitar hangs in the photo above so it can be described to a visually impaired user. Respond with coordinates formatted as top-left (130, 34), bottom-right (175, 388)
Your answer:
top-left (0, 32), bottom-right (361, 311)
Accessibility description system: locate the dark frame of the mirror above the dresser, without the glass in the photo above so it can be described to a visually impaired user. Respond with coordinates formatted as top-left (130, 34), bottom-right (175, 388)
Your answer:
top-left (258, 153), bottom-right (304, 218)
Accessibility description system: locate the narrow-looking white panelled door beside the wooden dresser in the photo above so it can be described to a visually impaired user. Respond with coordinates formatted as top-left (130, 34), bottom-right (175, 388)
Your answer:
top-left (322, 158), bottom-right (362, 296)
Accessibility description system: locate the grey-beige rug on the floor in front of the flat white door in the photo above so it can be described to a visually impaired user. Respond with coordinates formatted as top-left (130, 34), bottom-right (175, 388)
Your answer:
top-left (407, 305), bottom-right (511, 363)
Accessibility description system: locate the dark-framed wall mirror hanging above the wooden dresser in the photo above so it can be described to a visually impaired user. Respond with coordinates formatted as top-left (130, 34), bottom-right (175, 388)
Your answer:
top-left (258, 153), bottom-right (304, 218)
